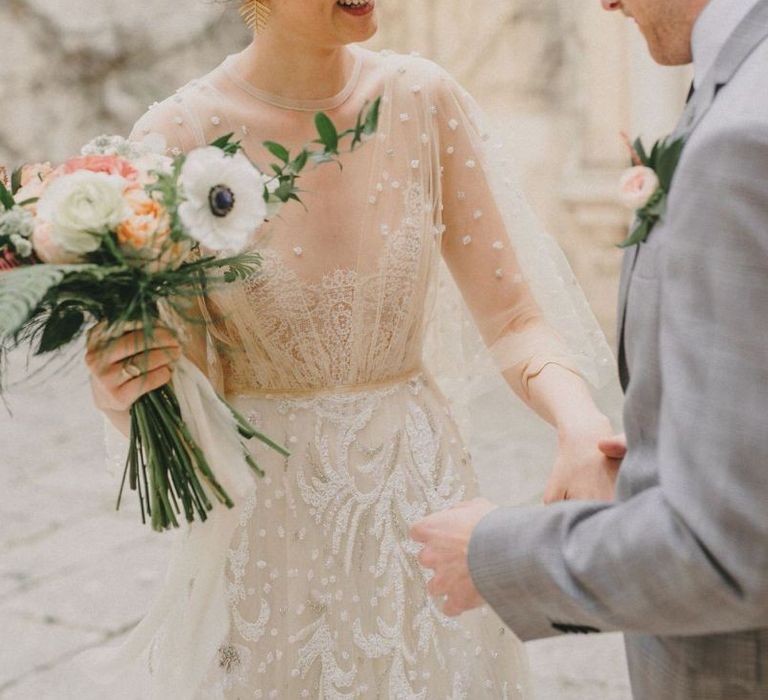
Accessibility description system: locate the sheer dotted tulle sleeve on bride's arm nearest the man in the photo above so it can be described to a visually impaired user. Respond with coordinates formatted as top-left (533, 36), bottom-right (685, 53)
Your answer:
top-left (428, 70), bottom-right (610, 394)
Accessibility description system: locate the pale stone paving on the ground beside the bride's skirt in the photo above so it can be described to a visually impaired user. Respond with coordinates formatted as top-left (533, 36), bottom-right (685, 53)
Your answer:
top-left (0, 355), bottom-right (630, 700)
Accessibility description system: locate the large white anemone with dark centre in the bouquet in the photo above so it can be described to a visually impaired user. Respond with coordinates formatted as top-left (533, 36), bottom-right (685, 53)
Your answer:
top-left (179, 146), bottom-right (267, 252)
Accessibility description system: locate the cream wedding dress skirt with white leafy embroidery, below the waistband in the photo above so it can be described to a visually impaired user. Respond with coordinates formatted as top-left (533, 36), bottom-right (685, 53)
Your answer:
top-left (196, 376), bottom-right (519, 700)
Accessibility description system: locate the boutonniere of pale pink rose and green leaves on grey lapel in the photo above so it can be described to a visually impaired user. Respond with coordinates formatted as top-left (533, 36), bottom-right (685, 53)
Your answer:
top-left (619, 134), bottom-right (685, 248)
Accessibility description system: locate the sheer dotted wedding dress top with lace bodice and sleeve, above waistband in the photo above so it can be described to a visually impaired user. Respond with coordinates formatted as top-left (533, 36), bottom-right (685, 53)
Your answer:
top-left (133, 47), bottom-right (608, 394)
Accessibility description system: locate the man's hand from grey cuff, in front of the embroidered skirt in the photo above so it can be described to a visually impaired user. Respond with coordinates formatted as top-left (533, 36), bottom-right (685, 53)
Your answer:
top-left (411, 498), bottom-right (498, 617)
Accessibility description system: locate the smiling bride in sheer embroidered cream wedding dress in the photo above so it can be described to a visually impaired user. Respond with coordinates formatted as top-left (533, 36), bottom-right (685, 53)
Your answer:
top-left (82, 0), bottom-right (613, 700)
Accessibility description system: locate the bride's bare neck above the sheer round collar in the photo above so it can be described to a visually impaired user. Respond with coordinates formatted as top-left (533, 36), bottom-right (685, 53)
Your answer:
top-left (238, 32), bottom-right (354, 100)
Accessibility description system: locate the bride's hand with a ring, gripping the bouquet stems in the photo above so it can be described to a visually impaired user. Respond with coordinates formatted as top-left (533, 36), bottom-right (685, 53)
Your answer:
top-left (85, 324), bottom-right (181, 413)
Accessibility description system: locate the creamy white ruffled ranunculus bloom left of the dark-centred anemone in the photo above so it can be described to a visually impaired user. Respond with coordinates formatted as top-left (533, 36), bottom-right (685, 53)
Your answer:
top-left (37, 170), bottom-right (131, 255)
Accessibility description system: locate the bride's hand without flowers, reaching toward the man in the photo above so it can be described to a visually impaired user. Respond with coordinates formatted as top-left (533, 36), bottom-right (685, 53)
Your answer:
top-left (544, 421), bottom-right (623, 504)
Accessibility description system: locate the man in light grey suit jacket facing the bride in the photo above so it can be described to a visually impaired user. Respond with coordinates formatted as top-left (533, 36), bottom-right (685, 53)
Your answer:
top-left (412, 0), bottom-right (768, 700)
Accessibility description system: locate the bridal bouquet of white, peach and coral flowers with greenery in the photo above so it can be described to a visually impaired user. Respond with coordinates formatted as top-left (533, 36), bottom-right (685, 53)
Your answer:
top-left (0, 101), bottom-right (379, 531)
